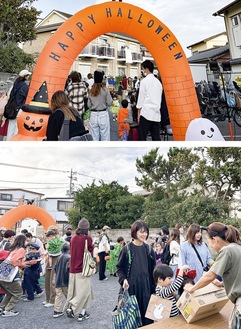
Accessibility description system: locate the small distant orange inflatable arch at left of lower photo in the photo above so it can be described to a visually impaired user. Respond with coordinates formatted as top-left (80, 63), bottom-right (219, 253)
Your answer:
top-left (0, 205), bottom-right (56, 230)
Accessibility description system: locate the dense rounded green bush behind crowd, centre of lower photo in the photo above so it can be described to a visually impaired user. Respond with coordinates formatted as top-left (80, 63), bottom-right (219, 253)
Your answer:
top-left (67, 181), bottom-right (144, 228)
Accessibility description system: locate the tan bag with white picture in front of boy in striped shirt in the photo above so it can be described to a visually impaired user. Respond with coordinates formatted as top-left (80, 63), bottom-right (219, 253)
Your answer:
top-left (145, 295), bottom-right (172, 321)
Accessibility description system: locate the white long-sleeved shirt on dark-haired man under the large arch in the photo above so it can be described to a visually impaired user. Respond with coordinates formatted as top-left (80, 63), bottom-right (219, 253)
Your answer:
top-left (136, 73), bottom-right (163, 122)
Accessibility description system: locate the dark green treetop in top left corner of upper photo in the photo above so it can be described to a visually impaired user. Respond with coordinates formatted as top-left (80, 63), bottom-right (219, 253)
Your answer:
top-left (0, 0), bottom-right (41, 45)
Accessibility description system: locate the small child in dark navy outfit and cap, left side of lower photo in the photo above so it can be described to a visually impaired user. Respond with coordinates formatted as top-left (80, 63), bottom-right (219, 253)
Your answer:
top-left (22, 243), bottom-right (44, 302)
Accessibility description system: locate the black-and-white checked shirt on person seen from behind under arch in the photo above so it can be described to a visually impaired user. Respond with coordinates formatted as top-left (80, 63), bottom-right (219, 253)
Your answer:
top-left (66, 82), bottom-right (87, 114)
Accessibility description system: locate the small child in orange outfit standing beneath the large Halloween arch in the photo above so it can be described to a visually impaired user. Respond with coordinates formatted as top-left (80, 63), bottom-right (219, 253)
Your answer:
top-left (117, 99), bottom-right (132, 140)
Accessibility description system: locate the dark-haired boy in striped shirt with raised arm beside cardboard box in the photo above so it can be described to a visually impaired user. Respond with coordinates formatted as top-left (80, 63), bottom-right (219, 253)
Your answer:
top-left (153, 264), bottom-right (190, 317)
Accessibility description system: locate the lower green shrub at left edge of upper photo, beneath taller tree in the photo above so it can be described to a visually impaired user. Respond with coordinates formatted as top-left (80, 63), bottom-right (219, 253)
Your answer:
top-left (0, 43), bottom-right (34, 73)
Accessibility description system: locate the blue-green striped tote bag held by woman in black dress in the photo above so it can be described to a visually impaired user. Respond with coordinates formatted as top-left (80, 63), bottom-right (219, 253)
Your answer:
top-left (112, 290), bottom-right (142, 329)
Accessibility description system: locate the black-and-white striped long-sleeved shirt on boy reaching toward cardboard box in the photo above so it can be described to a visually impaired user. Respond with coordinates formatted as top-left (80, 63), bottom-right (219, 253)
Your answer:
top-left (156, 275), bottom-right (183, 318)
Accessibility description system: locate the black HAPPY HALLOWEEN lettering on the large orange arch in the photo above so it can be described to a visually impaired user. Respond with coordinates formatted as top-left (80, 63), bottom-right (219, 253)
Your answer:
top-left (49, 8), bottom-right (183, 62)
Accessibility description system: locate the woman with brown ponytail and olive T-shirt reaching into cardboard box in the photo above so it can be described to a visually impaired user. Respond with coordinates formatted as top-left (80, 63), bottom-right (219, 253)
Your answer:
top-left (185, 222), bottom-right (241, 329)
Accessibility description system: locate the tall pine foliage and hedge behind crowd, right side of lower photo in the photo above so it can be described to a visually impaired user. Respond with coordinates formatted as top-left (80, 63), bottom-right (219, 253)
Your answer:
top-left (136, 147), bottom-right (241, 227)
